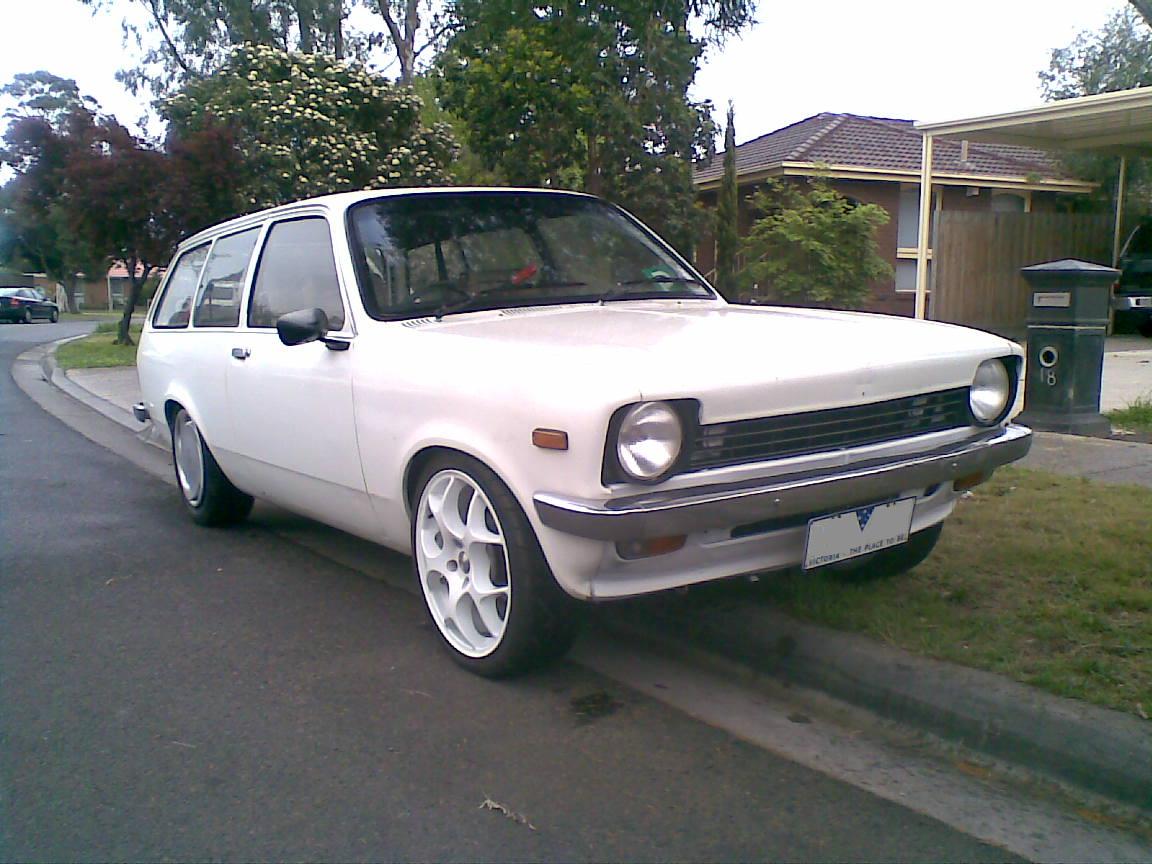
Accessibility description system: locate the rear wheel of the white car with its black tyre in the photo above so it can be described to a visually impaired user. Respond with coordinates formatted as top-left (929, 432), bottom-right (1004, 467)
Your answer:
top-left (168, 407), bottom-right (252, 528)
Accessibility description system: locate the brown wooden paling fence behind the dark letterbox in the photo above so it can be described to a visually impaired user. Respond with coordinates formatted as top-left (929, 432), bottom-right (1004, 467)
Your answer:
top-left (929, 210), bottom-right (1112, 336)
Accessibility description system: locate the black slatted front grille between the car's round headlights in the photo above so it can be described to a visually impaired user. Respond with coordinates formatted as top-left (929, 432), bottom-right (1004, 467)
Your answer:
top-left (685, 387), bottom-right (971, 470)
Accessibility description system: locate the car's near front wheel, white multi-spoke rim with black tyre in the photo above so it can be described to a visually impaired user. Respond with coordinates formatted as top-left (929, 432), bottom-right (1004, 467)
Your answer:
top-left (412, 454), bottom-right (578, 677)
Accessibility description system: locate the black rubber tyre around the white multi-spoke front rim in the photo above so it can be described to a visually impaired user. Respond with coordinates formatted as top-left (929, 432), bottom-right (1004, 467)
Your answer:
top-left (411, 454), bottom-right (583, 679)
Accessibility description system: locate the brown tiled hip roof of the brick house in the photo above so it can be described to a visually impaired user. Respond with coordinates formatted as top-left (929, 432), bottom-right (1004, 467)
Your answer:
top-left (694, 113), bottom-right (1071, 183)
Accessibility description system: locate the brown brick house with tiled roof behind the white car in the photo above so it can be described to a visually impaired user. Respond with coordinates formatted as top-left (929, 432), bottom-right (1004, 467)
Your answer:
top-left (694, 113), bottom-right (1092, 316)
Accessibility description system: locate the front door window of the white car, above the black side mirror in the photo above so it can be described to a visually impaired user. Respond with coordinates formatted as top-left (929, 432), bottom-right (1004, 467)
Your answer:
top-left (248, 217), bottom-right (344, 329)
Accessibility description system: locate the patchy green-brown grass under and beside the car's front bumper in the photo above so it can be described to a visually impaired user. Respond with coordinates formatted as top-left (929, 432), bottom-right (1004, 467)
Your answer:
top-left (741, 468), bottom-right (1152, 717)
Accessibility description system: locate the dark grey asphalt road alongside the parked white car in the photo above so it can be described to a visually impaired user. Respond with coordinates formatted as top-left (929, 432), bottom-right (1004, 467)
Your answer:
top-left (0, 324), bottom-right (1010, 861)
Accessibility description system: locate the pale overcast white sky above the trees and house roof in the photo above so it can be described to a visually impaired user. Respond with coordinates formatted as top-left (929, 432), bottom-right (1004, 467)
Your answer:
top-left (0, 0), bottom-right (1123, 142)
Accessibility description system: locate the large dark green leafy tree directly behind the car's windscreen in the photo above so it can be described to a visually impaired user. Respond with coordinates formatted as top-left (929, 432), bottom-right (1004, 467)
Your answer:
top-left (441, 0), bottom-right (755, 251)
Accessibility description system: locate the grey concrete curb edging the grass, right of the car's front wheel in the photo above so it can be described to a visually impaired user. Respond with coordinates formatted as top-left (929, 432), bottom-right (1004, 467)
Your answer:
top-left (605, 599), bottom-right (1152, 811)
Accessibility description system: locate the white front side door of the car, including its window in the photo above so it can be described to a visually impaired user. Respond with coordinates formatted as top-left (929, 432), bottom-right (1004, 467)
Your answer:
top-left (228, 215), bottom-right (377, 537)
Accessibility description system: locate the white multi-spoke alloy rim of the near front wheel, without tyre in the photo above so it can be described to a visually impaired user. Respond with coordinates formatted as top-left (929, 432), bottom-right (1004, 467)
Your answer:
top-left (414, 469), bottom-right (513, 658)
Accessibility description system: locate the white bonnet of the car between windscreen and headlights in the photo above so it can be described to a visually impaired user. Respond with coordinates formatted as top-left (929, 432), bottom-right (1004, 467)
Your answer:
top-left (396, 301), bottom-right (1021, 423)
